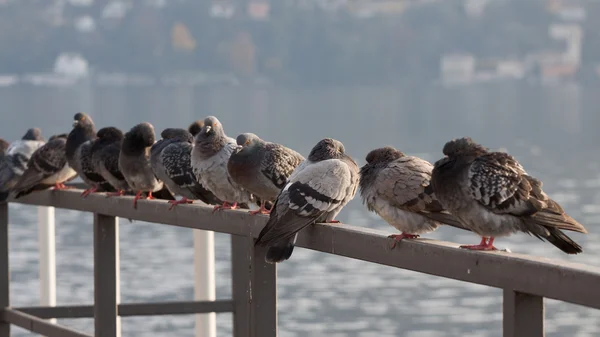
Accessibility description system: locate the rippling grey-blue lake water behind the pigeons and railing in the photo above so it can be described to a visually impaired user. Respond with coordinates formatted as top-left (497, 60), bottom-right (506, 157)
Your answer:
top-left (0, 84), bottom-right (600, 337)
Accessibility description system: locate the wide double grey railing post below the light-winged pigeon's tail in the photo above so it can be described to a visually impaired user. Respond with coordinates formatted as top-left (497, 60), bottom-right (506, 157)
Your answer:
top-left (231, 235), bottom-right (277, 337)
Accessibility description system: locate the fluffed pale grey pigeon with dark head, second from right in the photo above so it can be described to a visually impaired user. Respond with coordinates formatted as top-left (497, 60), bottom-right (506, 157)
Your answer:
top-left (359, 147), bottom-right (466, 248)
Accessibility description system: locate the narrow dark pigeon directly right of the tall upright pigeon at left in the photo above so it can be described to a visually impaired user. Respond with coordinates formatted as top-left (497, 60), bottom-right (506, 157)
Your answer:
top-left (91, 127), bottom-right (129, 197)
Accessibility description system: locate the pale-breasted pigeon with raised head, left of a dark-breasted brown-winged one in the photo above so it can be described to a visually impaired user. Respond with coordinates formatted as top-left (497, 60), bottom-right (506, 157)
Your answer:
top-left (191, 116), bottom-right (254, 212)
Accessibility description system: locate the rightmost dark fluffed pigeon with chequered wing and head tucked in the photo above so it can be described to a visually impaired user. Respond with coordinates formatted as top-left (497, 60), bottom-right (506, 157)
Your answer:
top-left (431, 137), bottom-right (587, 254)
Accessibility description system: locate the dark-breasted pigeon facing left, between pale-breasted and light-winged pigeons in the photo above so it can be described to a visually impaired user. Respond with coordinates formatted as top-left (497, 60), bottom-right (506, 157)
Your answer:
top-left (227, 133), bottom-right (304, 214)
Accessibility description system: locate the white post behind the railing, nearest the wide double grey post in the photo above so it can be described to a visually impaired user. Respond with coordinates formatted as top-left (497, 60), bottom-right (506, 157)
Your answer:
top-left (193, 230), bottom-right (217, 337)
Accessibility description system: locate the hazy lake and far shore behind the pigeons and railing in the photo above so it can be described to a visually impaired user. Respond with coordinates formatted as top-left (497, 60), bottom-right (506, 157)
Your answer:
top-left (0, 0), bottom-right (600, 337)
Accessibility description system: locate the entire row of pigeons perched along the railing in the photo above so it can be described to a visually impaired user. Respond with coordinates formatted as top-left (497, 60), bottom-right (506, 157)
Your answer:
top-left (0, 113), bottom-right (587, 262)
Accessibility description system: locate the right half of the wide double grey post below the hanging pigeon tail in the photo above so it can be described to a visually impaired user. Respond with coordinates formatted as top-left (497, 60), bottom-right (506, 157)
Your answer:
top-left (251, 242), bottom-right (277, 337)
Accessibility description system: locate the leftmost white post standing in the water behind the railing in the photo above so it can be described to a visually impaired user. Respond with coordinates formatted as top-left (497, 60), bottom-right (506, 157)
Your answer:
top-left (37, 206), bottom-right (56, 323)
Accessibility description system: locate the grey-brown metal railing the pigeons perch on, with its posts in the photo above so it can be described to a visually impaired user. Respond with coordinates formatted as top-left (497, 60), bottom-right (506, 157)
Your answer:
top-left (0, 186), bottom-right (600, 337)
